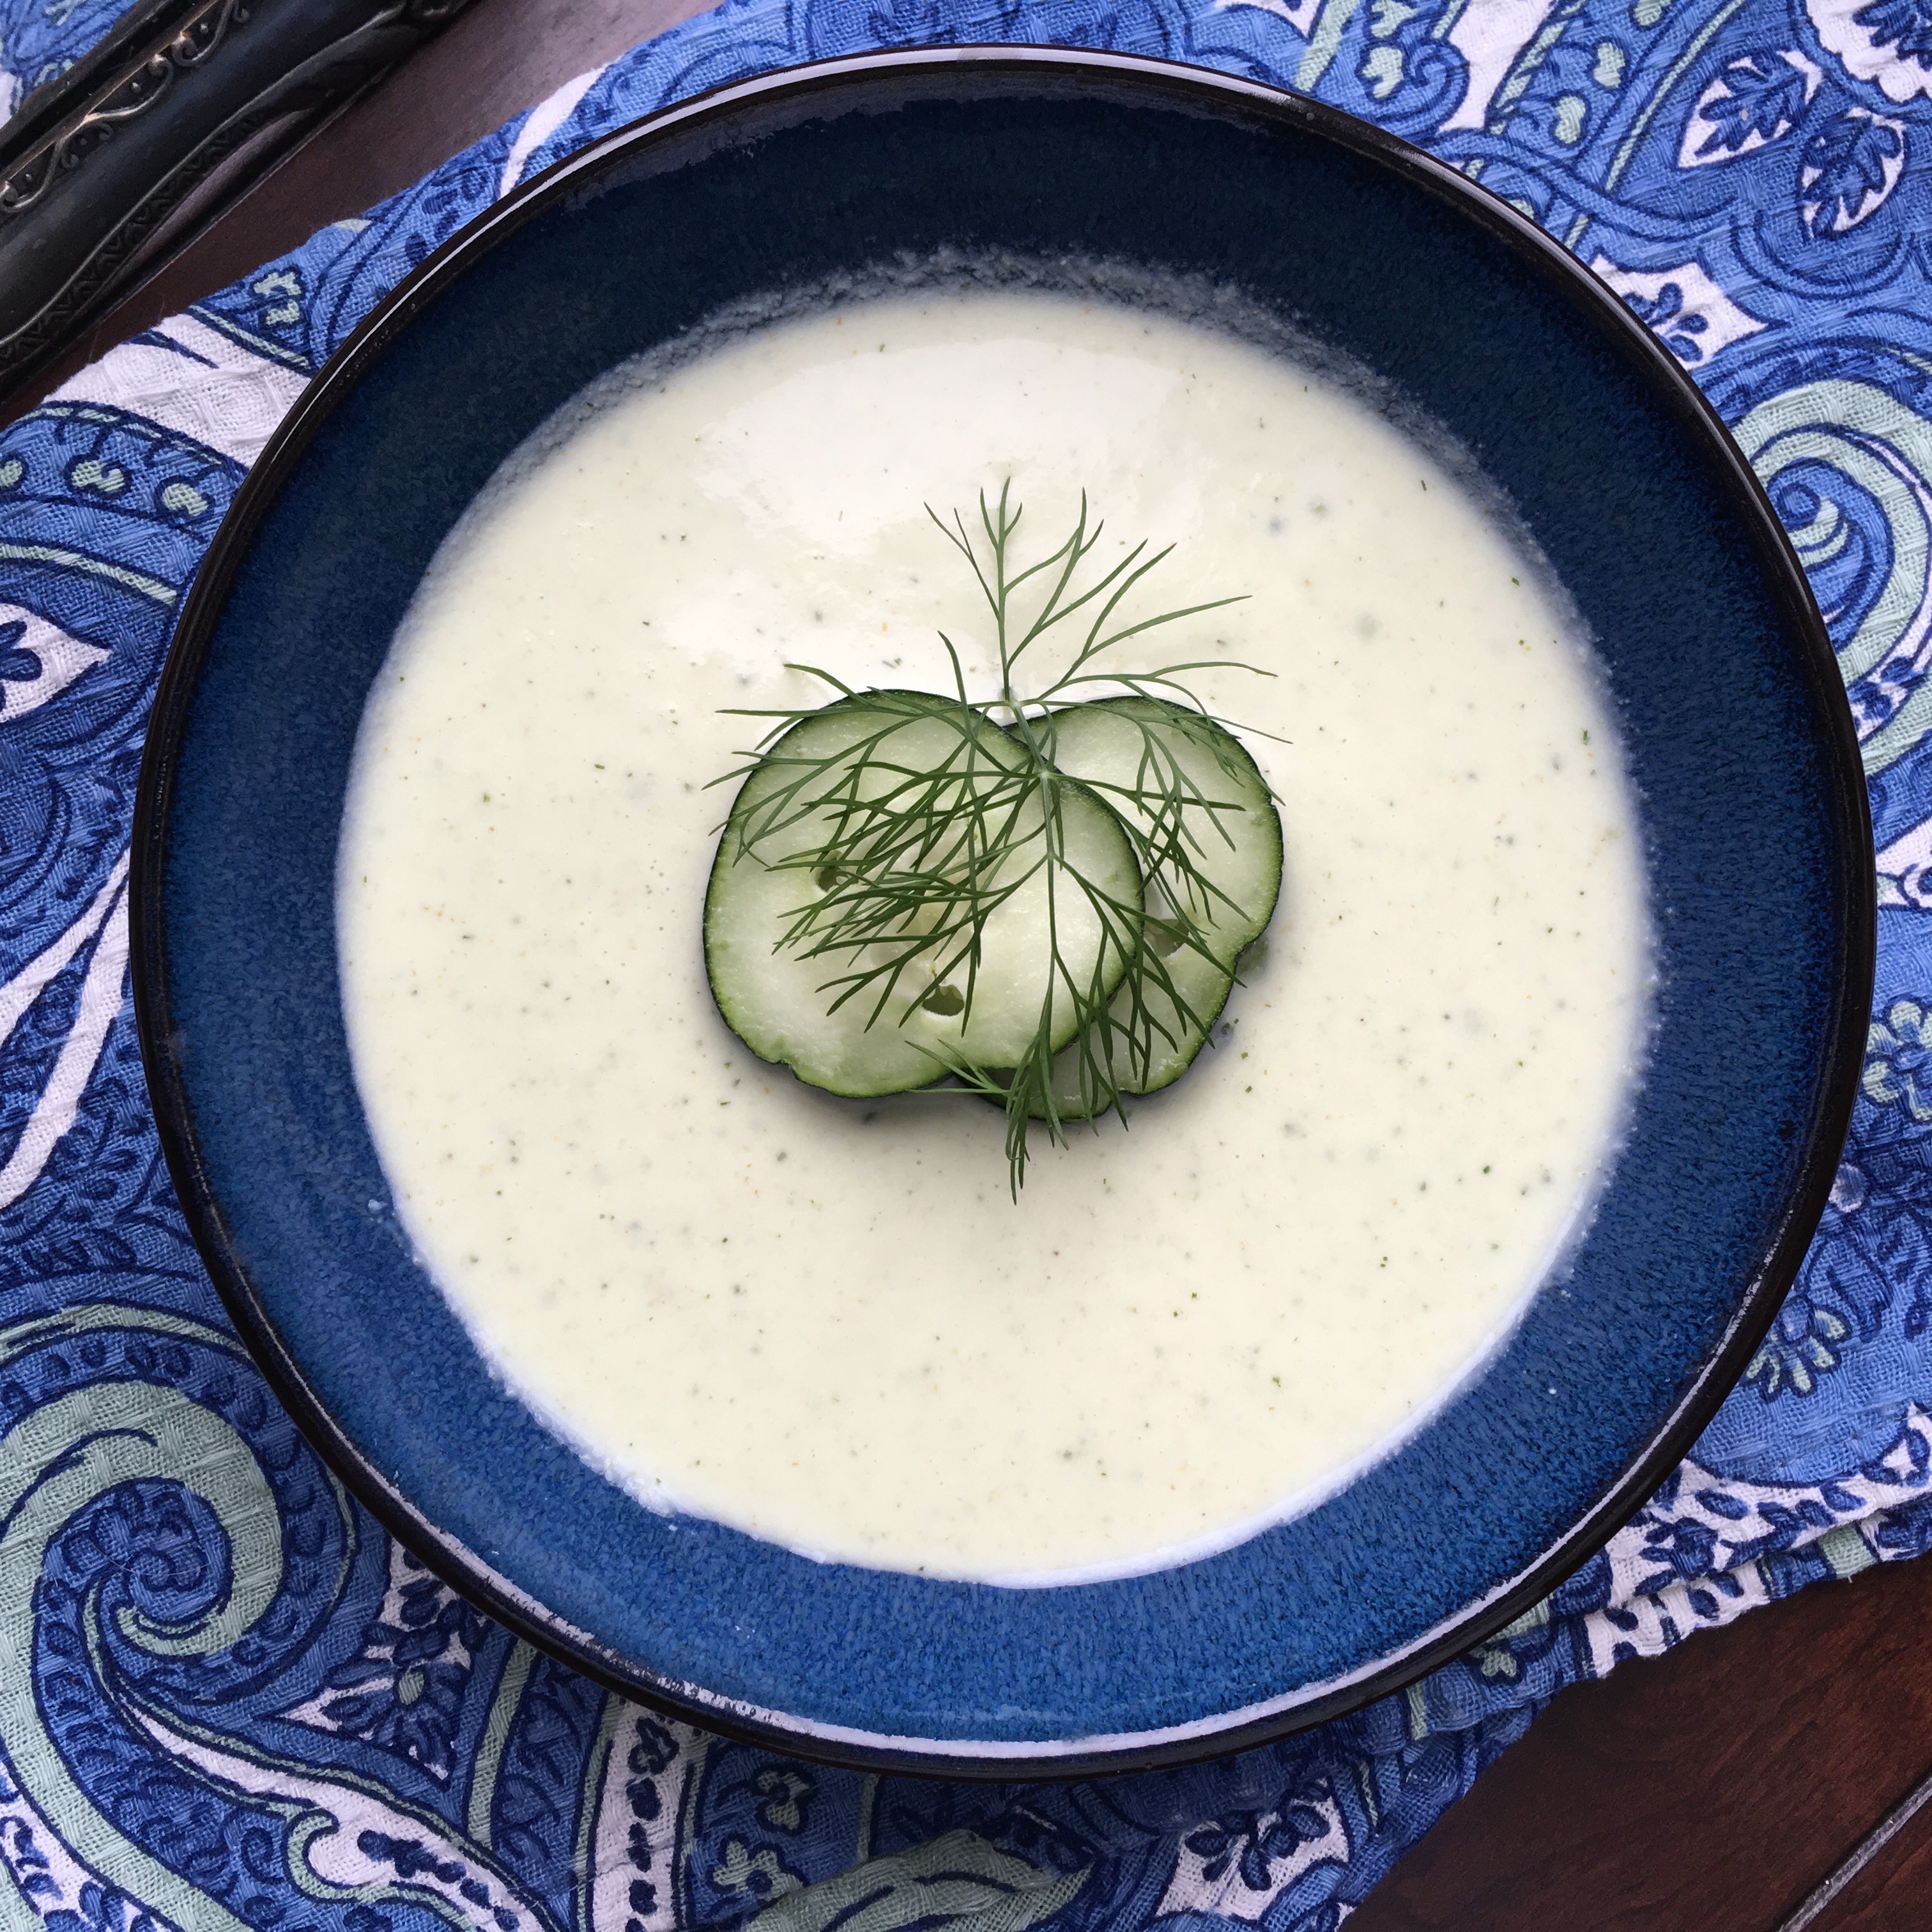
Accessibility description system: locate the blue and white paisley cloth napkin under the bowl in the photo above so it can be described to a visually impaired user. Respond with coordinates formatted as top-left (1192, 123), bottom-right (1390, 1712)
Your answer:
top-left (0, 0), bottom-right (1932, 1932)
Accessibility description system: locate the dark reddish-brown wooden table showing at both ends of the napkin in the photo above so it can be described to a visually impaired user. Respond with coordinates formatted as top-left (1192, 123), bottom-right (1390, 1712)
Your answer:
top-left (0, 0), bottom-right (1932, 1932)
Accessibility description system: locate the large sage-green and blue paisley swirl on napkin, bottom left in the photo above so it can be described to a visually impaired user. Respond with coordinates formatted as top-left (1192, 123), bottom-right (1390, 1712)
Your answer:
top-left (0, 1302), bottom-right (549, 1932)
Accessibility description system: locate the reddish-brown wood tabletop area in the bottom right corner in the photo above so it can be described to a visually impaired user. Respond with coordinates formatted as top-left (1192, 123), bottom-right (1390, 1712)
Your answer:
top-left (1349, 1561), bottom-right (1932, 1932)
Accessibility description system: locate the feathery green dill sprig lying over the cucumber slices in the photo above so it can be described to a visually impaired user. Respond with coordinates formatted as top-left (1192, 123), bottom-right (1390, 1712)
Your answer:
top-left (715, 479), bottom-right (1254, 1200)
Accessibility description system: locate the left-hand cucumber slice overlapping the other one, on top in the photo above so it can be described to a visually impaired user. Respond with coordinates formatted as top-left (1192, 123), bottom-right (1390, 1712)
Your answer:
top-left (705, 692), bottom-right (1142, 1096)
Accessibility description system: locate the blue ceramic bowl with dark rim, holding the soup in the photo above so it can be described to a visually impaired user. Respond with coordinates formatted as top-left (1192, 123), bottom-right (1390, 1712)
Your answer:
top-left (135, 50), bottom-right (1874, 1775)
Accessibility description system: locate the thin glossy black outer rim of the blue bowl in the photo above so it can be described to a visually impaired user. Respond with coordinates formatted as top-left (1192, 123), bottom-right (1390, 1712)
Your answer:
top-left (130, 43), bottom-right (1878, 1781)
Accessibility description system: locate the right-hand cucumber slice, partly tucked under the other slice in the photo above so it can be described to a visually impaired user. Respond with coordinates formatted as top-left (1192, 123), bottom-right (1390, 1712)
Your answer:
top-left (1034, 698), bottom-right (1281, 1121)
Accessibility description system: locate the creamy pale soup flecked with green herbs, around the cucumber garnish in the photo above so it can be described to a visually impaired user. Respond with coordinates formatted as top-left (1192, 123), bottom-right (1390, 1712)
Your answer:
top-left (340, 290), bottom-right (1650, 1579)
